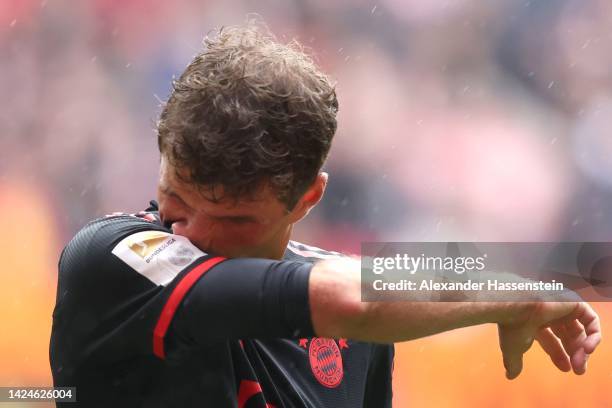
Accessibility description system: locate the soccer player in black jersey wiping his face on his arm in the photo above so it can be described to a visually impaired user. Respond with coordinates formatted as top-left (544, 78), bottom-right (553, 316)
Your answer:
top-left (50, 24), bottom-right (600, 408)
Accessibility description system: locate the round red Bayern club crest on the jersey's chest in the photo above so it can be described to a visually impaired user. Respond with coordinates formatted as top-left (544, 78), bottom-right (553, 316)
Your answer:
top-left (308, 337), bottom-right (344, 388)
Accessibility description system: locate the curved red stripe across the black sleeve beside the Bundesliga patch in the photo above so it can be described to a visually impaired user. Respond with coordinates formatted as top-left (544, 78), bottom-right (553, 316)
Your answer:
top-left (153, 257), bottom-right (225, 359)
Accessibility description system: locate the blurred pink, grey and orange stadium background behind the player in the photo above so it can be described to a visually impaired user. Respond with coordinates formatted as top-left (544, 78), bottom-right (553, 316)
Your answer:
top-left (0, 0), bottom-right (612, 408)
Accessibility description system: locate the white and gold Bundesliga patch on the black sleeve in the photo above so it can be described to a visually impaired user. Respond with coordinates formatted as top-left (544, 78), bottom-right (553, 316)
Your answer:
top-left (112, 231), bottom-right (206, 286)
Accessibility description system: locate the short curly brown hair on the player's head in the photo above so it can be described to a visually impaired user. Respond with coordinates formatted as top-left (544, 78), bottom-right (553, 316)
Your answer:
top-left (157, 21), bottom-right (338, 209)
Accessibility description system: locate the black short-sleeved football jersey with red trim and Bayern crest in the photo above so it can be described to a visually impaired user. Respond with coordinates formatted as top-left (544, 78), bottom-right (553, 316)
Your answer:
top-left (50, 202), bottom-right (393, 408)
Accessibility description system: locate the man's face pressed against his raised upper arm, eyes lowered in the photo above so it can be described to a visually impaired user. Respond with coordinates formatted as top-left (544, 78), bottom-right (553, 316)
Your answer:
top-left (158, 158), bottom-right (306, 259)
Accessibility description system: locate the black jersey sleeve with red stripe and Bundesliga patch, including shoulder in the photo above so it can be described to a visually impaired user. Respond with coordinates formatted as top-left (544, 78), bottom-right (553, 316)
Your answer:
top-left (51, 216), bottom-right (313, 375)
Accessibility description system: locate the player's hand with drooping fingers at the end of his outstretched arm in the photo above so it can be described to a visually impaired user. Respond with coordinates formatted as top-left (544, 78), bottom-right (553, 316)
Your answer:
top-left (498, 302), bottom-right (601, 380)
